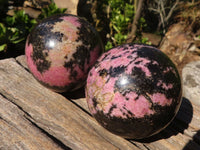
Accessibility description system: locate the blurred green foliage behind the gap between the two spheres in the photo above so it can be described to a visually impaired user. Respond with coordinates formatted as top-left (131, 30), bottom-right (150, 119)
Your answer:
top-left (95, 0), bottom-right (150, 50)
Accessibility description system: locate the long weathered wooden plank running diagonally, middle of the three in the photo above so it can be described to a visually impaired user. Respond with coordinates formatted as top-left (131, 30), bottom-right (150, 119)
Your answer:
top-left (0, 59), bottom-right (138, 150)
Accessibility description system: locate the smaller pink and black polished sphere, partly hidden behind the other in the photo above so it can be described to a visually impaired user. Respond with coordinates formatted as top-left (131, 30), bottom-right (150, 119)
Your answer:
top-left (25, 14), bottom-right (103, 92)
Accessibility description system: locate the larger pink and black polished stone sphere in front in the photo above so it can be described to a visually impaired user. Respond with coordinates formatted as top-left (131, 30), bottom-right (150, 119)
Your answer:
top-left (86, 44), bottom-right (182, 139)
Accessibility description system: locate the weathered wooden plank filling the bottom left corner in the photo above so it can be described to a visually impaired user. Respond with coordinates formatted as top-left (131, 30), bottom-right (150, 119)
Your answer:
top-left (0, 95), bottom-right (62, 150)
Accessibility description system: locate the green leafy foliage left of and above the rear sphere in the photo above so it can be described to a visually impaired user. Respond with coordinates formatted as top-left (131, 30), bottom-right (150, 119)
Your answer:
top-left (0, 1), bottom-right (67, 56)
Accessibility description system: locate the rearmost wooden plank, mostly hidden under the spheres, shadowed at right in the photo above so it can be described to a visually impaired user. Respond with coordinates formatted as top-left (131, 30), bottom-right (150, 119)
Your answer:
top-left (17, 56), bottom-right (200, 150)
